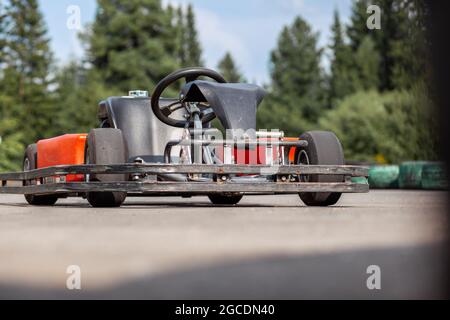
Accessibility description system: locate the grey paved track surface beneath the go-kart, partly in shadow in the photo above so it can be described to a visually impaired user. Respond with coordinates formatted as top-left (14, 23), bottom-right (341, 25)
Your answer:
top-left (0, 191), bottom-right (448, 299)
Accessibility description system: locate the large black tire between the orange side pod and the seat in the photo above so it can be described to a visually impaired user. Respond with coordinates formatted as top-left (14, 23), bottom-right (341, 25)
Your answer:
top-left (85, 128), bottom-right (128, 208)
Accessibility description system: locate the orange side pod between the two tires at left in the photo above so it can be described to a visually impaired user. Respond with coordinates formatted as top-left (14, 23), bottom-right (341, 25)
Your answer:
top-left (37, 134), bottom-right (87, 182)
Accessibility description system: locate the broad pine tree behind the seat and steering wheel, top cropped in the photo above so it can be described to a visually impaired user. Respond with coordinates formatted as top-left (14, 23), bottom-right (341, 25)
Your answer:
top-left (85, 0), bottom-right (177, 93)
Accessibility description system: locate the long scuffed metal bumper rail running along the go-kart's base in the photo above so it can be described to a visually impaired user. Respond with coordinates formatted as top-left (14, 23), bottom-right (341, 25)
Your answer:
top-left (0, 164), bottom-right (369, 195)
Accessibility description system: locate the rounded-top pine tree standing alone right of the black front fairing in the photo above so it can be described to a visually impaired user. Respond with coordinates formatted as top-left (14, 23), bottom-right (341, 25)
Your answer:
top-left (258, 17), bottom-right (326, 135)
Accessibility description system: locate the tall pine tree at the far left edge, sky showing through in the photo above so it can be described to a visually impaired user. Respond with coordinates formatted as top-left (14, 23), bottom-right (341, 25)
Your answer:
top-left (4, 0), bottom-right (53, 142)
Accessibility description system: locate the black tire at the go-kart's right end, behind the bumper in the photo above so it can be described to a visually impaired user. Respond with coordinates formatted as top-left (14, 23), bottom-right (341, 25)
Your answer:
top-left (295, 131), bottom-right (345, 207)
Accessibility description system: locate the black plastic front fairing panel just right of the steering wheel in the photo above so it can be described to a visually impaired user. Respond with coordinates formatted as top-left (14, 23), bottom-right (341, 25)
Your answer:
top-left (182, 80), bottom-right (266, 131)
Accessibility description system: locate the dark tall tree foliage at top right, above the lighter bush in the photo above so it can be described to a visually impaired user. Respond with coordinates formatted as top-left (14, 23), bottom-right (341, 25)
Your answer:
top-left (348, 0), bottom-right (426, 90)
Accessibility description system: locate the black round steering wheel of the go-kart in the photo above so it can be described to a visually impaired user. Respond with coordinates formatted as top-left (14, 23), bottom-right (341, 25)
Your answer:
top-left (151, 67), bottom-right (227, 128)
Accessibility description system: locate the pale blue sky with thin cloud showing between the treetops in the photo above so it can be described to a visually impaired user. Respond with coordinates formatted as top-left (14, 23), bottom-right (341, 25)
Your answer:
top-left (39, 0), bottom-right (351, 84)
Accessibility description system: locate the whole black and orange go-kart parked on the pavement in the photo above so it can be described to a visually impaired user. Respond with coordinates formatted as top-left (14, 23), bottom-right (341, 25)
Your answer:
top-left (0, 68), bottom-right (369, 207)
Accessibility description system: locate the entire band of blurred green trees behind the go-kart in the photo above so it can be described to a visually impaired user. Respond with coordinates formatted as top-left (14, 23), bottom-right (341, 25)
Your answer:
top-left (0, 0), bottom-right (438, 171)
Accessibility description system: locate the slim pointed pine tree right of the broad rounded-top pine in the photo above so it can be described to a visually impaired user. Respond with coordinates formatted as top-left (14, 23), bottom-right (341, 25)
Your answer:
top-left (329, 10), bottom-right (356, 105)
